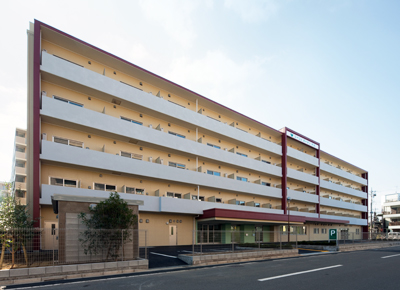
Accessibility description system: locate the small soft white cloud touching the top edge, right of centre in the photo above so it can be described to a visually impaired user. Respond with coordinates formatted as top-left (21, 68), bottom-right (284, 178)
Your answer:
top-left (224, 0), bottom-right (278, 23)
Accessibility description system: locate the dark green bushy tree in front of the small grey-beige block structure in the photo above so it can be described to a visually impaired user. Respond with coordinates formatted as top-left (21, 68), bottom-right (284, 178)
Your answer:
top-left (79, 192), bottom-right (137, 260)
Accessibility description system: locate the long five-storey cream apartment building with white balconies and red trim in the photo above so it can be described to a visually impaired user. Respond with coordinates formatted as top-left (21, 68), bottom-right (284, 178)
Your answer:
top-left (28, 20), bottom-right (368, 245)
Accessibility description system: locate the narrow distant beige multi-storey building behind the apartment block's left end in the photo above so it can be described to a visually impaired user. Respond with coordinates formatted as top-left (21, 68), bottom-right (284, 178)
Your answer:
top-left (11, 128), bottom-right (27, 205)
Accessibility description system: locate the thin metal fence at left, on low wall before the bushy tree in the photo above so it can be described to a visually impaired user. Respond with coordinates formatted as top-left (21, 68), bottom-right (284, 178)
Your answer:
top-left (0, 228), bottom-right (147, 269)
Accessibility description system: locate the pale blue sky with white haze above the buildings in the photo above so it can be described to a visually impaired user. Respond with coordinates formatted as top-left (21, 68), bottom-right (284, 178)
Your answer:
top-left (0, 0), bottom-right (400, 210)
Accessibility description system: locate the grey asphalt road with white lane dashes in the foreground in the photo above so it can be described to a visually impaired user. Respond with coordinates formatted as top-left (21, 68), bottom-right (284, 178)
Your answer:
top-left (6, 247), bottom-right (400, 290)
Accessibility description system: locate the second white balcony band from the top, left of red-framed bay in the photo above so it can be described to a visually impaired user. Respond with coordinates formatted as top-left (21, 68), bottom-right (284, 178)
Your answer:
top-left (41, 97), bottom-right (282, 177)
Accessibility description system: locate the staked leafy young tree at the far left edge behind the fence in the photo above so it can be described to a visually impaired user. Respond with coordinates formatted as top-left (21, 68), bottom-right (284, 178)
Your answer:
top-left (0, 187), bottom-right (35, 269)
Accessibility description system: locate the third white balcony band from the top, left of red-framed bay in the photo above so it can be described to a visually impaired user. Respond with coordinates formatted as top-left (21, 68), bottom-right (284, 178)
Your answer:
top-left (40, 140), bottom-right (282, 198)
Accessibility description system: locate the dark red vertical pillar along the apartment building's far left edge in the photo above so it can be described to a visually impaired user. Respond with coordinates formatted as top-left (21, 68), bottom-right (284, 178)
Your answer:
top-left (32, 20), bottom-right (41, 227)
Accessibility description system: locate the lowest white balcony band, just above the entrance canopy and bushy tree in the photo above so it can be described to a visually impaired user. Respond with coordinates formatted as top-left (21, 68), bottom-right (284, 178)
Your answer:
top-left (40, 184), bottom-right (283, 215)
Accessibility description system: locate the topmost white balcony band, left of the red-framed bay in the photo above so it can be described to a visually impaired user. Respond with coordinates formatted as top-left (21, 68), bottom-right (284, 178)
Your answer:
top-left (41, 52), bottom-right (282, 155)
